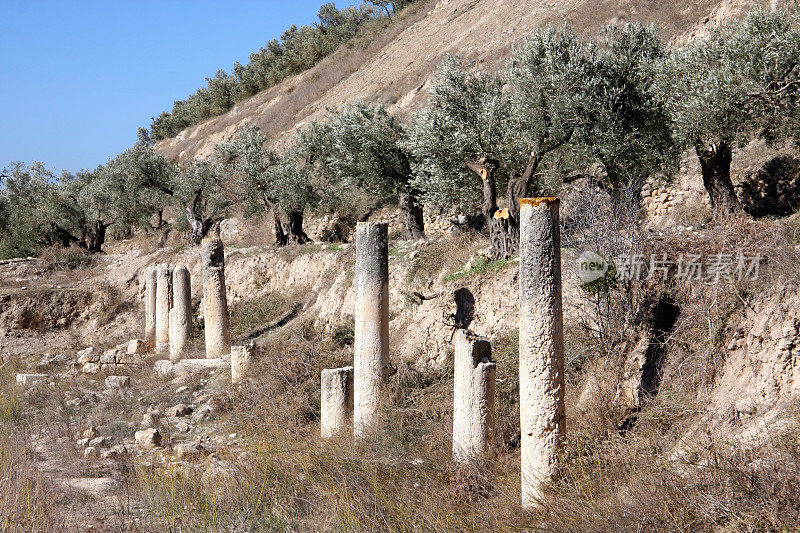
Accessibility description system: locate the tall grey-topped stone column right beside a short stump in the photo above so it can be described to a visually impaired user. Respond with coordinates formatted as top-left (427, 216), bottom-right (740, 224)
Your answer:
top-left (353, 222), bottom-right (389, 438)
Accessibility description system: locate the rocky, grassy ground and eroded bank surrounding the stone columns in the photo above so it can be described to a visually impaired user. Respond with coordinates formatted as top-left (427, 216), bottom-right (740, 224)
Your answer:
top-left (0, 167), bottom-right (800, 531)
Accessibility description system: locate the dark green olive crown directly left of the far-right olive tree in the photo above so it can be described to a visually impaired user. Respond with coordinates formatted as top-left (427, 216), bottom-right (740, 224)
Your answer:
top-left (575, 23), bottom-right (680, 200)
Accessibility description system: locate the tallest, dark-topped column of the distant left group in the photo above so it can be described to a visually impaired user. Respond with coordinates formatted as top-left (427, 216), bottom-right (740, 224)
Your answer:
top-left (201, 237), bottom-right (231, 359)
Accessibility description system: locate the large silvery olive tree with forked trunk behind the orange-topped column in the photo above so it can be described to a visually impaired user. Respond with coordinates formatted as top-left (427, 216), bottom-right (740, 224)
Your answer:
top-left (408, 27), bottom-right (592, 259)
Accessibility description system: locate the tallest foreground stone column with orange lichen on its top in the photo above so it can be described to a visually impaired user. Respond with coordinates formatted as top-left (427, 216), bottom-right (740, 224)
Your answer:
top-left (519, 198), bottom-right (565, 509)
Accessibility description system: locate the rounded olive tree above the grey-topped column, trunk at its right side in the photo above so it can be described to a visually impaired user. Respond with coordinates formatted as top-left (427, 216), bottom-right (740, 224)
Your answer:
top-left (299, 100), bottom-right (425, 239)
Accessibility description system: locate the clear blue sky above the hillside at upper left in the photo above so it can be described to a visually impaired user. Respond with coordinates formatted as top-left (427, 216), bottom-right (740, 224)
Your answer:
top-left (0, 0), bottom-right (357, 171)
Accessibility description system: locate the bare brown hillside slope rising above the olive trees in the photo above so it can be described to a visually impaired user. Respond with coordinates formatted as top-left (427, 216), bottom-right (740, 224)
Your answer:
top-left (157, 0), bottom-right (774, 160)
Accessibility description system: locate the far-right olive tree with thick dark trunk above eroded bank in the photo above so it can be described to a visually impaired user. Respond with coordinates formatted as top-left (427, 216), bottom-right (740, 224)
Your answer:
top-left (662, 7), bottom-right (800, 216)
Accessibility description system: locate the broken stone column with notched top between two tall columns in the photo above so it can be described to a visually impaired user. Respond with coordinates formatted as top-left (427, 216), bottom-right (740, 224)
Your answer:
top-left (453, 329), bottom-right (497, 463)
